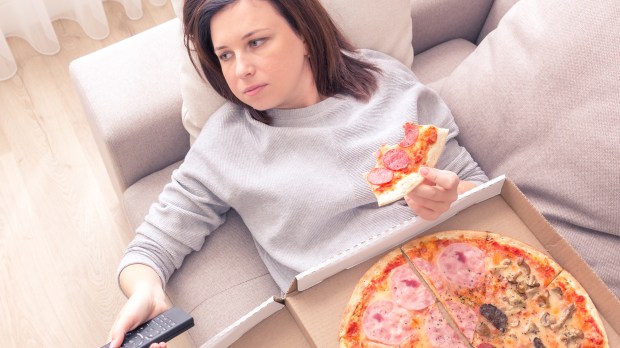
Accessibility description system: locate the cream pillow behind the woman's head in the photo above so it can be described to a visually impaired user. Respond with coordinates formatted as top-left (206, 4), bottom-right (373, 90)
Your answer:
top-left (173, 0), bottom-right (413, 143)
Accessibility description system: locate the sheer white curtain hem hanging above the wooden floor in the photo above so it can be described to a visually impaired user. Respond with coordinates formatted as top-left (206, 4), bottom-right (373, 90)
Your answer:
top-left (0, 0), bottom-right (168, 81)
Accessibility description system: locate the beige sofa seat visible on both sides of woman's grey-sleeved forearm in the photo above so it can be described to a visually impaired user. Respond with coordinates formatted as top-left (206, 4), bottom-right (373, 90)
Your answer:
top-left (123, 162), bottom-right (280, 346)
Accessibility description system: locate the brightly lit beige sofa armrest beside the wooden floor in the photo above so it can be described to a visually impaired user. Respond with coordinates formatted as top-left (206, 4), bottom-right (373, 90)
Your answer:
top-left (70, 19), bottom-right (189, 196)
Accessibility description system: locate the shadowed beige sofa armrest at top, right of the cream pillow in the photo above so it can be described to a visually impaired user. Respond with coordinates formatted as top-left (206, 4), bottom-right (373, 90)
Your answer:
top-left (411, 0), bottom-right (493, 54)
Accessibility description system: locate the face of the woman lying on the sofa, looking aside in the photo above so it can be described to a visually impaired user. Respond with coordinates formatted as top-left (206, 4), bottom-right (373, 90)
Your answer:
top-left (211, 0), bottom-right (320, 111)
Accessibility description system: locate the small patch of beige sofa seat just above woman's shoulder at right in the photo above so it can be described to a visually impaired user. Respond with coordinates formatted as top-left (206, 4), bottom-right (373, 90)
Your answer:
top-left (411, 39), bottom-right (476, 91)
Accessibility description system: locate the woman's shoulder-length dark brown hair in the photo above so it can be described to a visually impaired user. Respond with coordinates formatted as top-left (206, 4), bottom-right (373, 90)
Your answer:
top-left (183, 0), bottom-right (379, 123)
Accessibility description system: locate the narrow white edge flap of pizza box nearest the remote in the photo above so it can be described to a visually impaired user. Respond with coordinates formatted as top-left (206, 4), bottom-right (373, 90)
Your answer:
top-left (200, 297), bottom-right (284, 348)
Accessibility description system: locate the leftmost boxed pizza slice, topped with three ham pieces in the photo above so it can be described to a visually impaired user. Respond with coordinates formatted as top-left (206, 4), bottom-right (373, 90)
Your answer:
top-left (339, 249), bottom-right (467, 348)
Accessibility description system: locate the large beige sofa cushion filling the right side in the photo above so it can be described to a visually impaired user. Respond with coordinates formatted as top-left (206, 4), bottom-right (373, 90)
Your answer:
top-left (440, 0), bottom-right (620, 297)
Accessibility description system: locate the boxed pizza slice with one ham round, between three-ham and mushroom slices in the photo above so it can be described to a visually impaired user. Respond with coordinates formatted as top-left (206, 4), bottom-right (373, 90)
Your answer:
top-left (402, 231), bottom-right (487, 342)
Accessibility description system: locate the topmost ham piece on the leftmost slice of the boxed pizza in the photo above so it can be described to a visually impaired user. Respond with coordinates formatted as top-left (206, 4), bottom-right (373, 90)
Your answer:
top-left (390, 265), bottom-right (435, 311)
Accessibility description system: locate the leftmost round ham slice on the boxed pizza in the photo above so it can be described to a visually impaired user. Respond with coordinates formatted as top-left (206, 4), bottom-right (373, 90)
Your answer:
top-left (362, 300), bottom-right (414, 345)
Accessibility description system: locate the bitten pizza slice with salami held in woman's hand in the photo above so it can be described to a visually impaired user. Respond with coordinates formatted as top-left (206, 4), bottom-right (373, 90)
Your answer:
top-left (363, 122), bottom-right (448, 206)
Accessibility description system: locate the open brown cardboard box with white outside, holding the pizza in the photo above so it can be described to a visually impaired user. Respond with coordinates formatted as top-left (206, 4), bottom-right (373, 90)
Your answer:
top-left (203, 176), bottom-right (620, 348)
